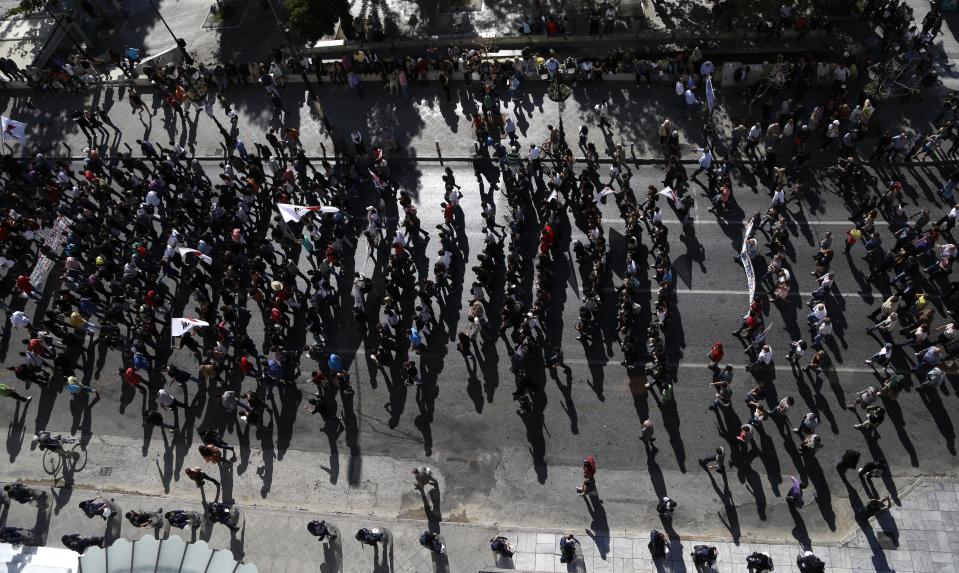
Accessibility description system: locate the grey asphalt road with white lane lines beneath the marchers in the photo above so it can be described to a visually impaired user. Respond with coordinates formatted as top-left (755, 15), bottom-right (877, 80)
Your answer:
top-left (0, 150), bottom-right (959, 539)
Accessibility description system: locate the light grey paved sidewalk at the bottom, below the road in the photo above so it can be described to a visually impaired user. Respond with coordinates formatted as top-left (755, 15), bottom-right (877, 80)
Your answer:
top-left (0, 474), bottom-right (959, 573)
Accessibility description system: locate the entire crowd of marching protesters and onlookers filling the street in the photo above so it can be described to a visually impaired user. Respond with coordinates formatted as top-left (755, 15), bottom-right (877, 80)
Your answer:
top-left (0, 0), bottom-right (959, 570)
